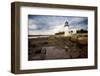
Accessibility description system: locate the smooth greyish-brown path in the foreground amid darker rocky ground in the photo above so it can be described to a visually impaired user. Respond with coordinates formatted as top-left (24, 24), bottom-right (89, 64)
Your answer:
top-left (45, 47), bottom-right (70, 59)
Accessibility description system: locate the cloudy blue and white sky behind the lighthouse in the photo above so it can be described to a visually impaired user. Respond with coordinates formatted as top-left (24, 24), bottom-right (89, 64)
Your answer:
top-left (28, 15), bottom-right (88, 35)
